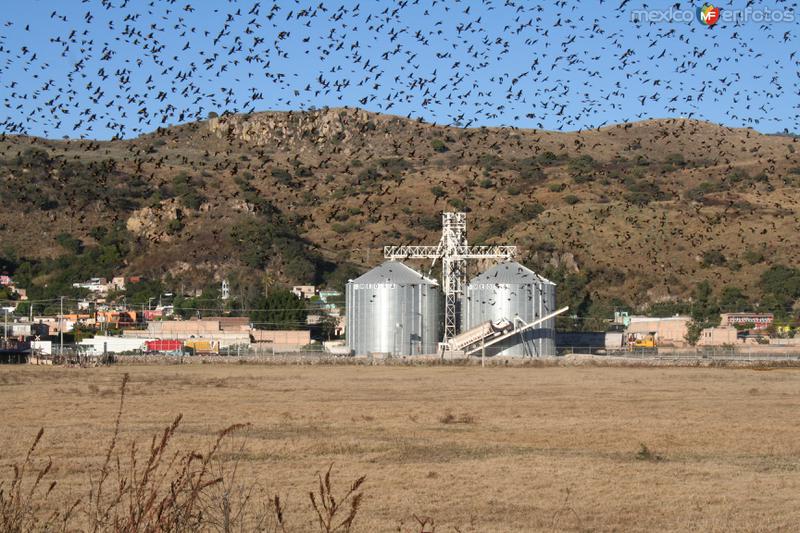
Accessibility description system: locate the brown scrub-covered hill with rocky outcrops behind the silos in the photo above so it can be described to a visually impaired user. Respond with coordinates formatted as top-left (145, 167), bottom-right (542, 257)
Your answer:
top-left (0, 109), bottom-right (800, 322)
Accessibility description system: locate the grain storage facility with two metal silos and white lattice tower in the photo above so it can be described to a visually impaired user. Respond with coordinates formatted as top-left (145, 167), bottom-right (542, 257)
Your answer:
top-left (346, 213), bottom-right (567, 357)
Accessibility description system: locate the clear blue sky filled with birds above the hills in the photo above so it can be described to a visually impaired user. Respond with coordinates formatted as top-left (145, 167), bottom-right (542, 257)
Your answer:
top-left (0, 0), bottom-right (800, 139)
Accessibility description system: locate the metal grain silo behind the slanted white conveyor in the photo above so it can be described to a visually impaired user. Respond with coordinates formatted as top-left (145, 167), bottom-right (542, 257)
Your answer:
top-left (462, 261), bottom-right (556, 357)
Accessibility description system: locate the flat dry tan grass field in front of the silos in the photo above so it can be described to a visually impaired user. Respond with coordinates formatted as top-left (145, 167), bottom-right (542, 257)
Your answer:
top-left (0, 365), bottom-right (800, 532)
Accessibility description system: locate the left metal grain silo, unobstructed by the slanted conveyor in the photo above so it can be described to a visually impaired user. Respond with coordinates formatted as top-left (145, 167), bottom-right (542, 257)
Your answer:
top-left (345, 261), bottom-right (441, 355)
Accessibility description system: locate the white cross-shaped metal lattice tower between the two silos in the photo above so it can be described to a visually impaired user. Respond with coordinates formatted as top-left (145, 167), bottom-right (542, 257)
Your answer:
top-left (383, 213), bottom-right (517, 342)
